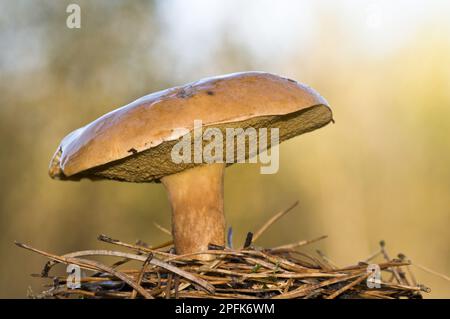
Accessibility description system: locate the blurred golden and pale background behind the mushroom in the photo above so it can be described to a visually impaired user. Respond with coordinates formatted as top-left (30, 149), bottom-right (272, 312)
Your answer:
top-left (0, 0), bottom-right (450, 298)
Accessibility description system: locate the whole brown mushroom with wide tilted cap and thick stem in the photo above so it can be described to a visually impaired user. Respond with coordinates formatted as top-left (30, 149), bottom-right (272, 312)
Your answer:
top-left (49, 72), bottom-right (332, 259)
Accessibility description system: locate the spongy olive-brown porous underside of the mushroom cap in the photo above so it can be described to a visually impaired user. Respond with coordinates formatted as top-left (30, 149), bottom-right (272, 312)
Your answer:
top-left (70, 105), bottom-right (332, 183)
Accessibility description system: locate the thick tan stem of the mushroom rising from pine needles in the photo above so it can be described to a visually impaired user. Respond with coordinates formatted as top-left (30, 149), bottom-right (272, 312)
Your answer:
top-left (161, 163), bottom-right (225, 260)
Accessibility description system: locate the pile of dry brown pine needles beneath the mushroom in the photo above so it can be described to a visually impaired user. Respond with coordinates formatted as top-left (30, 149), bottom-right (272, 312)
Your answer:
top-left (16, 203), bottom-right (430, 299)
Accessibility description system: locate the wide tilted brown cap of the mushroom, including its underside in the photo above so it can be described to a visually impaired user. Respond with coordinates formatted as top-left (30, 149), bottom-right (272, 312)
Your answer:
top-left (49, 72), bottom-right (332, 182)
